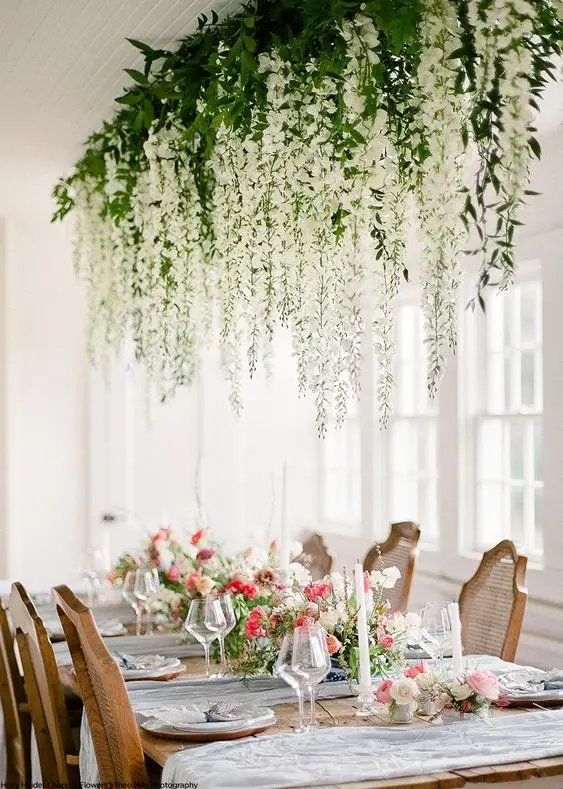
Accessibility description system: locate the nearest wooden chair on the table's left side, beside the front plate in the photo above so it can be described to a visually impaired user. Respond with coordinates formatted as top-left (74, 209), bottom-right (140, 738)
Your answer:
top-left (53, 586), bottom-right (149, 787)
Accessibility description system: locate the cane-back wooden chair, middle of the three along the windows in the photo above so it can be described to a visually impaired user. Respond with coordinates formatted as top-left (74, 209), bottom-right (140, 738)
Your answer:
top-left (364, 521), bottom-right (420, 611)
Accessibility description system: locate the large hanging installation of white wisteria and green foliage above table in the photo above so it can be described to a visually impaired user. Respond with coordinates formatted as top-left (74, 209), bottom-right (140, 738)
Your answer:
top-left (51, 0), bottom-right (562, 432)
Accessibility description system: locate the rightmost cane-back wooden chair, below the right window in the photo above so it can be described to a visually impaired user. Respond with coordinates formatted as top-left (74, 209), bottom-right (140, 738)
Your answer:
top-left (459, 540), bottom-right (528, 662)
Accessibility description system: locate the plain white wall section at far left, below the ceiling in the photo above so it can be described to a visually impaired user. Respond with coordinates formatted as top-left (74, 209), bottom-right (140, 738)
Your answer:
top-left (0, 159), bottom-right (87, 586)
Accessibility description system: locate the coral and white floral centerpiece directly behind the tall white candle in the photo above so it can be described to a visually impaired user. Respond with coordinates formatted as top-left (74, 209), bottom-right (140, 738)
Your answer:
top-left (236, 565), bottom-right (420, 677)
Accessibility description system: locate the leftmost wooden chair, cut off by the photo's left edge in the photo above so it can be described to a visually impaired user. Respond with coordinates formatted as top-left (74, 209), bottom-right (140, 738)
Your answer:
top-left (0, 602), bottom-right (31, 787)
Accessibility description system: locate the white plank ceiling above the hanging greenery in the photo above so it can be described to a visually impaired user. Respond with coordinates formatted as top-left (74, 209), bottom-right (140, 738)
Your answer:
top-left (0, 0), bottom-right (563, 166)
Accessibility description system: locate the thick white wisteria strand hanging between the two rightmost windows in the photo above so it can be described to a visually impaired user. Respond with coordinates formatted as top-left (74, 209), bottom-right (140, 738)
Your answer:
top-left (416, 0), bottom-right (467, 396)
